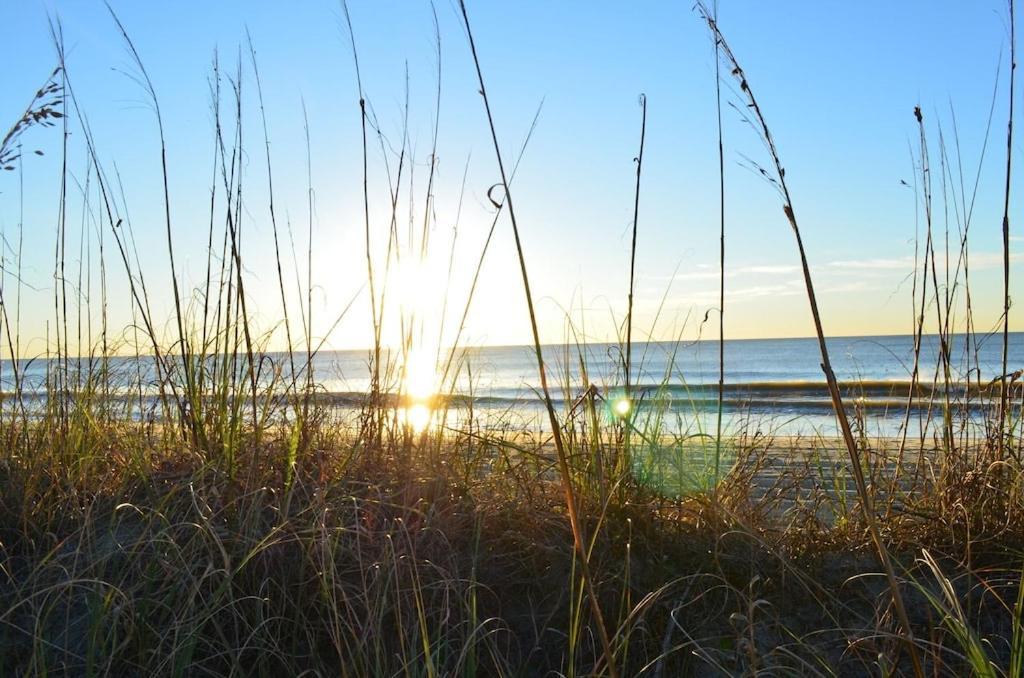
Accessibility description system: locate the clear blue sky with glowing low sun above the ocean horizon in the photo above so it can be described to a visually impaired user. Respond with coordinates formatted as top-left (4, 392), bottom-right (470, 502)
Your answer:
top-left (0, 0), bottom-right (1024, 355)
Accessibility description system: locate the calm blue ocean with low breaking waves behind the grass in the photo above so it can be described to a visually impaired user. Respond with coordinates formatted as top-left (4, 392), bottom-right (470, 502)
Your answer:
top-left (9, 333), bottom-right (1024, 435)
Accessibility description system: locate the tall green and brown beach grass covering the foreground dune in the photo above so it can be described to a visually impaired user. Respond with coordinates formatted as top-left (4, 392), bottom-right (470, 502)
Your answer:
top-left (0, 1), bottom-right (1024, 676)
